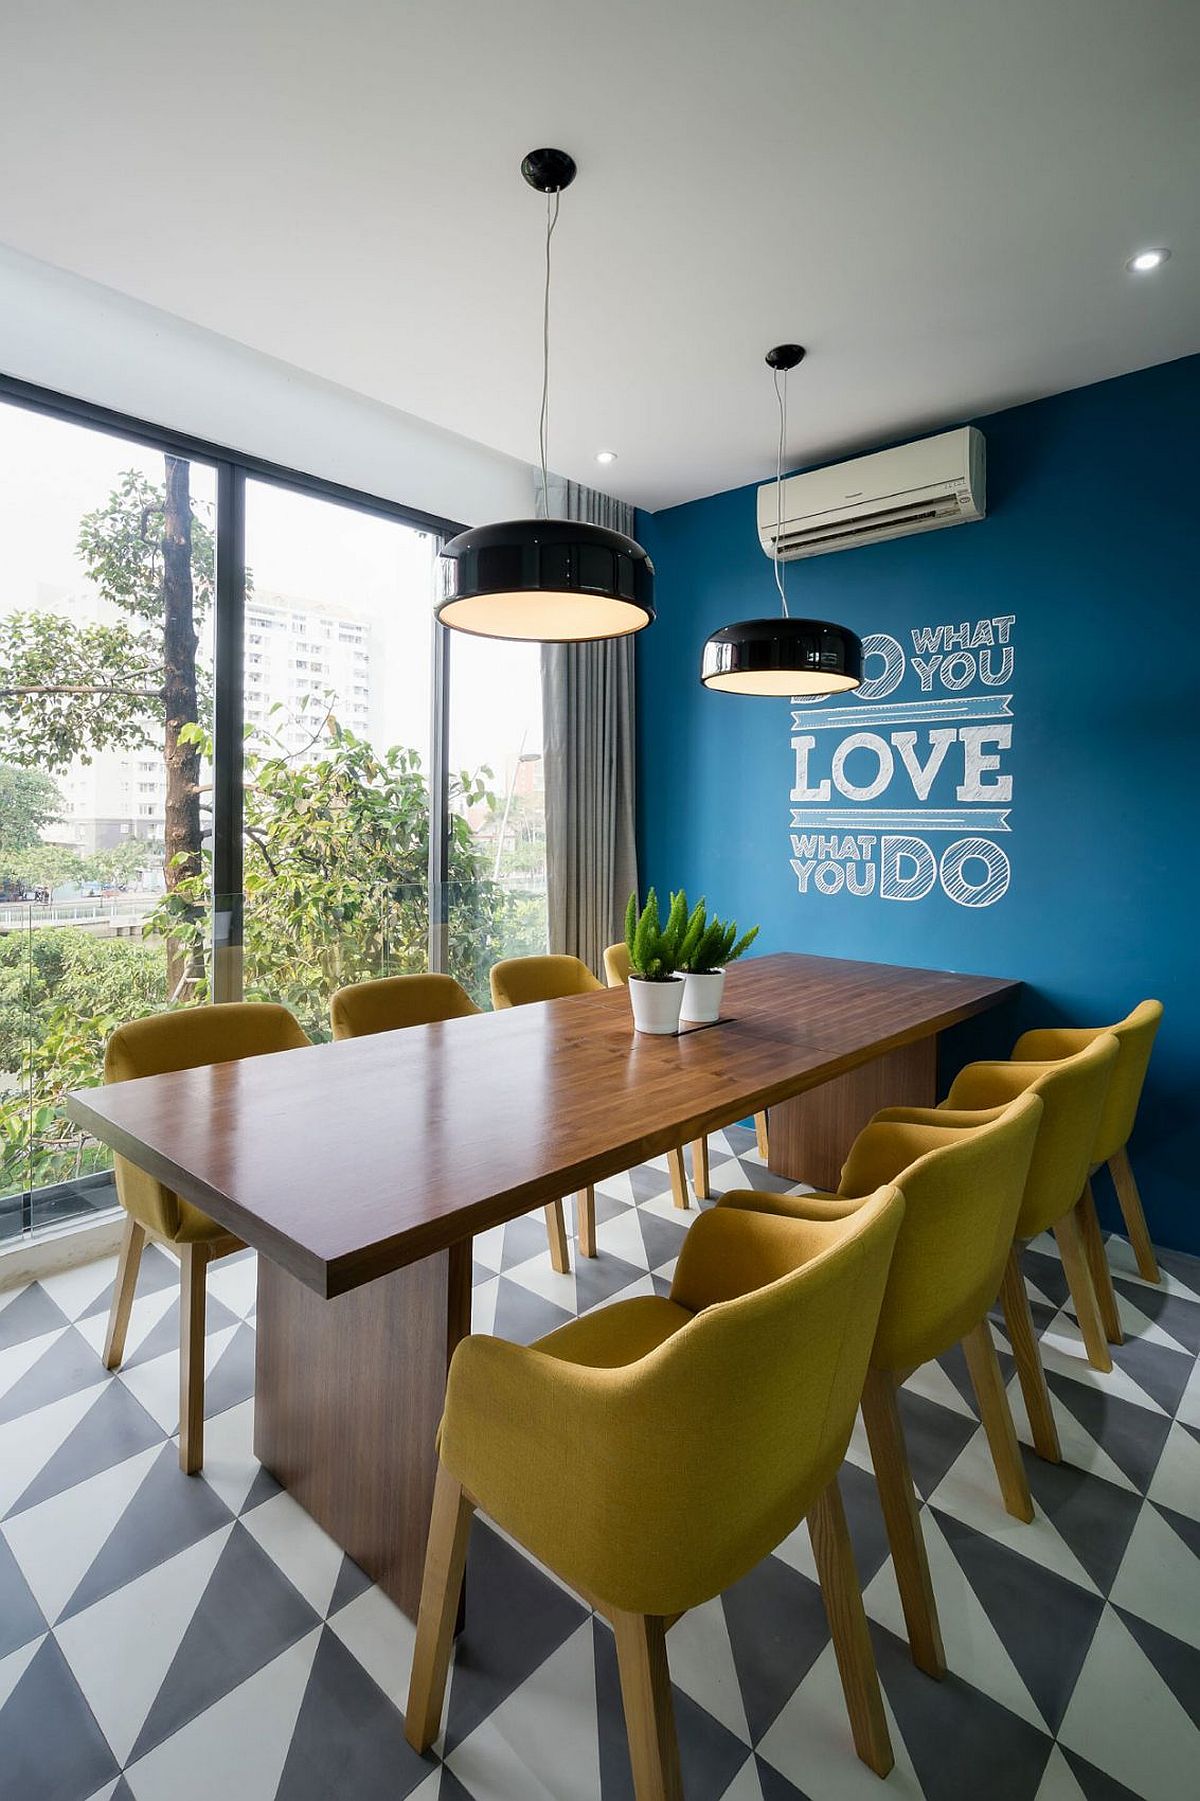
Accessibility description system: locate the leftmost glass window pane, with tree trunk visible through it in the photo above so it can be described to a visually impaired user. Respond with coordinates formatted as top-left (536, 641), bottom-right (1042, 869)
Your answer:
top-left (0, 405), bottom-right (216, 1237)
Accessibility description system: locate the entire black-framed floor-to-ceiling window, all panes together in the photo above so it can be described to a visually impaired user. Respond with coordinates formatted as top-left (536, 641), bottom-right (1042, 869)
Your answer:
top-left (0, 384), bottom-right (546, 1241)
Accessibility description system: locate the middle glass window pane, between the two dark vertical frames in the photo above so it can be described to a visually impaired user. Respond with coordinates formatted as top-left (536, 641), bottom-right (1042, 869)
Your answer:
top-left (234, 481), bottom-right (438, 1037)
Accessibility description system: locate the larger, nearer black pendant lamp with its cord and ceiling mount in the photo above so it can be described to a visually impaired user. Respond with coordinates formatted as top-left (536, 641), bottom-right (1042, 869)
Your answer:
top-left (436, 149), bottom-right (654, 643)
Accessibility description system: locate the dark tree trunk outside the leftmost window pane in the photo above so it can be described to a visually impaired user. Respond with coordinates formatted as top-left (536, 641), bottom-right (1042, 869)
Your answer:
top-left (162, 456), bottom-right (204, 994)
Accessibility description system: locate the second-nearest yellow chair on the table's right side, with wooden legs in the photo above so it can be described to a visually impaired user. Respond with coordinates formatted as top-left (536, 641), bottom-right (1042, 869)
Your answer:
top-left (717, 1095), bottom-right (1041, 1677)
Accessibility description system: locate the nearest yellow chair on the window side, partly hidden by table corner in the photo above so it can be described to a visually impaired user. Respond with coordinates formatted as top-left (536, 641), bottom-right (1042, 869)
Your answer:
top-left (105, 1001), bottom-right (308, 1475)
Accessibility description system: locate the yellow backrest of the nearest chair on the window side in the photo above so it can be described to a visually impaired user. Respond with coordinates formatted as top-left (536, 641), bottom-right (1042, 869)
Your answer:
top-left (105, 1001), bottom-right (310, 1239)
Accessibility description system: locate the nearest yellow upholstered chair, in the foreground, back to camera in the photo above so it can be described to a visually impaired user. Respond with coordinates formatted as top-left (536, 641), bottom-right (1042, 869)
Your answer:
top-left (405, 1187), bottom-right (903, 1801)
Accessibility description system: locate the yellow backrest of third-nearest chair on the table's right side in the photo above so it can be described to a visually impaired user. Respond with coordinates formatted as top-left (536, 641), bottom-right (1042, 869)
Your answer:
top-left (944, 1032), bottom-right (1117, 1239)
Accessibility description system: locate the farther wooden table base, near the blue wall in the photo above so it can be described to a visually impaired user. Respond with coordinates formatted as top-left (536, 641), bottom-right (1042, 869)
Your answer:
top-left (769, 1034), bottom-right (937, 1190)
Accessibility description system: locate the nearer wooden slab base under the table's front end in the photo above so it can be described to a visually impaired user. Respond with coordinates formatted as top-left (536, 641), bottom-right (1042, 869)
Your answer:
top-left (254, 1241), bottom-right (470, 1619)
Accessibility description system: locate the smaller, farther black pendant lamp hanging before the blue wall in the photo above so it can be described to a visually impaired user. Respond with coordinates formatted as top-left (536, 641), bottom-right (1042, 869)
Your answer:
top-left (701, 344), bottom-right (863, 695)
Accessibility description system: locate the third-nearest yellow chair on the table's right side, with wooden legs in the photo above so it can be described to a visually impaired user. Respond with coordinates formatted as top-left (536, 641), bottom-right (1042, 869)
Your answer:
top-left (915, 1032), bottom-right (1123, 1462)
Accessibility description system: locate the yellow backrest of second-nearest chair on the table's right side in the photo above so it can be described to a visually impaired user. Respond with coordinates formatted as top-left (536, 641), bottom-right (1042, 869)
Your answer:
top-left (838, 1093), bottom-right (1041, 1372)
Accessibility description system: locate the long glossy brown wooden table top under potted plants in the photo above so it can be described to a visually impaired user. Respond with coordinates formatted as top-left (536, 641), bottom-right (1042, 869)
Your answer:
top-left (65, 953), bottom-right (1020, 1295)
